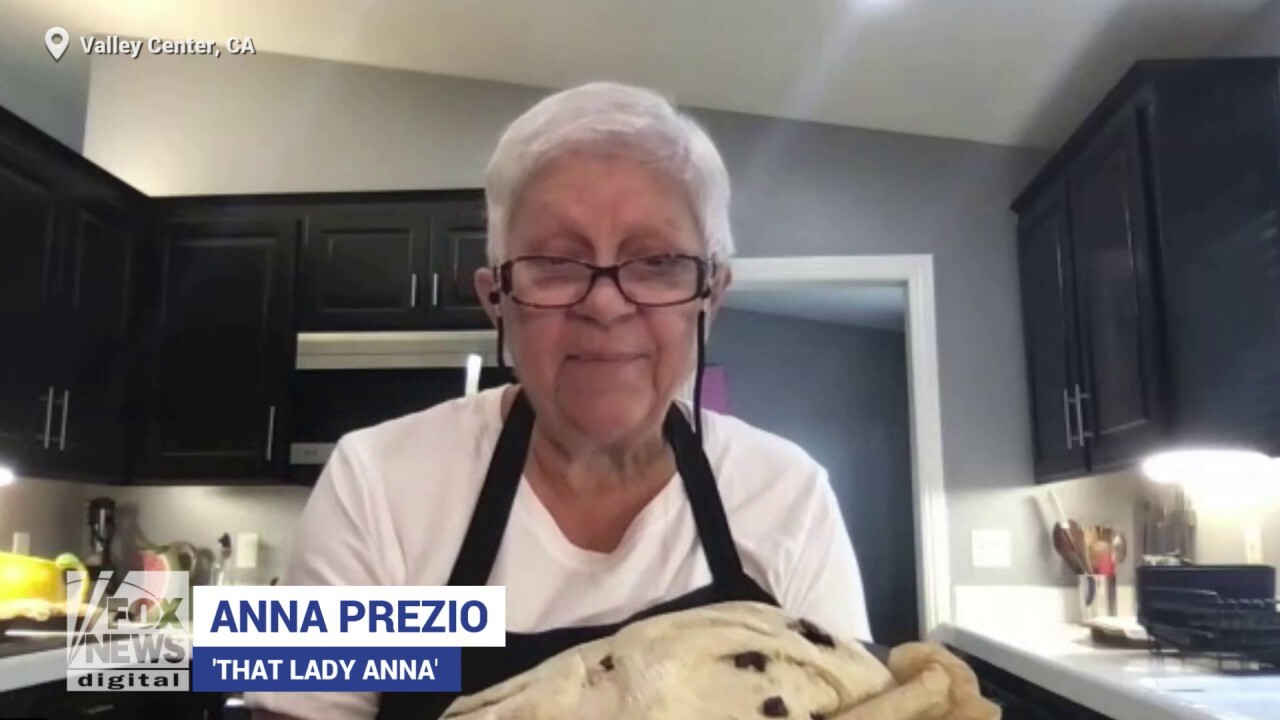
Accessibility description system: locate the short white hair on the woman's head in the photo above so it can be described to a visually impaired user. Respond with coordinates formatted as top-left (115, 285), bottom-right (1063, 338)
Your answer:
top-left (485, 82), bottom-right (733, 264)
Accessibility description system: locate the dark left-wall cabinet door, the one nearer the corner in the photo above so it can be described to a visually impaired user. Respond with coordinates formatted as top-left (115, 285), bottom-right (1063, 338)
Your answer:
top-left (54, 204), bottom-right (140, 482)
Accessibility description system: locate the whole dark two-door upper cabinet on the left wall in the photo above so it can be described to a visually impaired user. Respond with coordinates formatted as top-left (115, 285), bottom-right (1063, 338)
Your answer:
top-left (0, 106), bottom-right (146, 483)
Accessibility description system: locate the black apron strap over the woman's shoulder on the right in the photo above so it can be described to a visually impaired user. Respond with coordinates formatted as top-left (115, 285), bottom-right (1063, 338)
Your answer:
top-left (663, 405), bottom-right (746, 591)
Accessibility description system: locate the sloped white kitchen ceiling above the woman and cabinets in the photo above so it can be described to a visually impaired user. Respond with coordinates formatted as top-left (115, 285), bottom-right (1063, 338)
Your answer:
top-left (0, 0), bottom-right (1266, 146)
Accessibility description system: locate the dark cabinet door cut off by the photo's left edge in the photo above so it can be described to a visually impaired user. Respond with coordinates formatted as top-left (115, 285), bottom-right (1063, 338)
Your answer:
top-left (0, 161), bottom-right (59, 471)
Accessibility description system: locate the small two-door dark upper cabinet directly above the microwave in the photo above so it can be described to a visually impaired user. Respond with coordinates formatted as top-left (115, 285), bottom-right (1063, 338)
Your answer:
top-left (298, 193), bottom-right (490, 332)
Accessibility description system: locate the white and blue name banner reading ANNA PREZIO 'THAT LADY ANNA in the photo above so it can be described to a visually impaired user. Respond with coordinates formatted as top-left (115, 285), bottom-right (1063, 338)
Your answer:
top-left (191, 585), bottom-right (507, 692)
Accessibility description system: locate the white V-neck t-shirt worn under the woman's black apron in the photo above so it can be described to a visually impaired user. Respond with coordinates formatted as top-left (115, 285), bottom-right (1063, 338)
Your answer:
top-left (246, 388), bottom-right (872, 720)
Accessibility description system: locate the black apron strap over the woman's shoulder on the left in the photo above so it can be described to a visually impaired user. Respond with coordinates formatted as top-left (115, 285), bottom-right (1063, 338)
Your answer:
top-left (449, 389), bottom-right (534, 587)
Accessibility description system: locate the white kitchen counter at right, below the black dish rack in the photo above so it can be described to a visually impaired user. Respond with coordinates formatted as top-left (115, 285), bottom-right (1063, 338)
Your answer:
top-left (931, 624), bottom-right (1280, 720)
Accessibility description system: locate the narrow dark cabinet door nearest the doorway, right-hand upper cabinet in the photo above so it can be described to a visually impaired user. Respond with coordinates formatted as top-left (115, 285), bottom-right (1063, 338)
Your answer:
top-left (1018, 188), bottom-right (1088, 480)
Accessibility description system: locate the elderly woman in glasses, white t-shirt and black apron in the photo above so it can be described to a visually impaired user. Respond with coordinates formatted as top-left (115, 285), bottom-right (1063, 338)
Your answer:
top-left (248, 83), bottom-right (870, 720)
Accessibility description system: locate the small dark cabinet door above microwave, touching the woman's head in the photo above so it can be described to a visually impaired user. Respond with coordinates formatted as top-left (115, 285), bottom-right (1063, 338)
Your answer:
top-left (431, 200), bottom-right (493, 329)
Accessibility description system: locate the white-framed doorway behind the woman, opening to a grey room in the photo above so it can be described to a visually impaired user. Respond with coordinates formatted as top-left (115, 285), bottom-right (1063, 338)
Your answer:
top-left (708, 255), bottom-right (951, 635)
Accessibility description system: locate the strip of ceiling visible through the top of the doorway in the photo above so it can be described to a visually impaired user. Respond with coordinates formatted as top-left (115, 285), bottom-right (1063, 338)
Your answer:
top-left (724, 283), bottom-right (906, 332)
